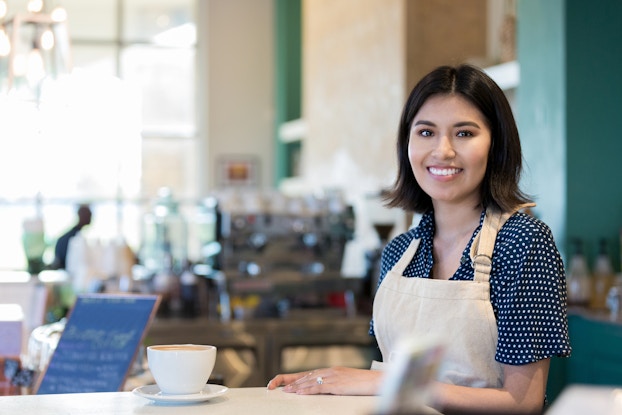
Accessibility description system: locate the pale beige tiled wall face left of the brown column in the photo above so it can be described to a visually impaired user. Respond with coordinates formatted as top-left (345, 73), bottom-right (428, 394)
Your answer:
top-left (302, 0), bottom-right (405, 198)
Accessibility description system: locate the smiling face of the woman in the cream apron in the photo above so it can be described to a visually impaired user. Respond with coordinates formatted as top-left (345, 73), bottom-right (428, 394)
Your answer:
top-left (408, 95), bottom-right (491, 207)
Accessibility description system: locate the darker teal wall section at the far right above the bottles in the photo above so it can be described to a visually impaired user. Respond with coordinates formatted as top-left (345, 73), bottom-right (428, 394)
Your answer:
top-left (566, 0), bottom-right (622, 269)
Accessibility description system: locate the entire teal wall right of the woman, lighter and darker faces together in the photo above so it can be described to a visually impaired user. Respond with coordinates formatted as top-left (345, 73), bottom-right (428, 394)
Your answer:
top-left (516, 0), bottom-right (622, 271)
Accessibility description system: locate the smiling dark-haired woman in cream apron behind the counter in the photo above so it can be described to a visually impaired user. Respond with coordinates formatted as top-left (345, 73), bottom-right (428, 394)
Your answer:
top-left (268, 65), bottom-right (570, 414)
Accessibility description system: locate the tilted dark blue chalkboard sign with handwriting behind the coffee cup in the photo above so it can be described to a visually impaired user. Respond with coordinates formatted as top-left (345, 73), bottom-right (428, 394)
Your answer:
top-left (35, 294), bottom-right (160, 394)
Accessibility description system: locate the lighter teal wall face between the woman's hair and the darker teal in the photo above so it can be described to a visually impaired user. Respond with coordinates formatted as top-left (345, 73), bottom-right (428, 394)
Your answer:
top-left (516, 0), bottom-right (566, 256)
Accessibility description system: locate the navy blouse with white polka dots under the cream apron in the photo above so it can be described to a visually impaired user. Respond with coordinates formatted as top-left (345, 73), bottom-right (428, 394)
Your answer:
top-left (370, 212), bottom-right (570, 365)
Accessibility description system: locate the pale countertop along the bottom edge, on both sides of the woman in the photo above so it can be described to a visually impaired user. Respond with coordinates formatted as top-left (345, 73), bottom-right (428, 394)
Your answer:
top-left (0, 385), bottom-right (622, 415)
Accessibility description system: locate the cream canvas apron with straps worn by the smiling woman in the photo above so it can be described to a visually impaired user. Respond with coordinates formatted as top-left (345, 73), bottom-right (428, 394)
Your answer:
top-left (372, 212), bottom-right (524, 387)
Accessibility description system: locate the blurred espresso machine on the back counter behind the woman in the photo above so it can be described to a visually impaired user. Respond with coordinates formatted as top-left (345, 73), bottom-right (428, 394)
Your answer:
top-left (214, 193), bottom-right (359, 317)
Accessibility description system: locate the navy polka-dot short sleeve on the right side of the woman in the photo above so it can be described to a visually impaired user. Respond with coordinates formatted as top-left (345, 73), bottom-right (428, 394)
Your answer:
top-left (490, 213), bottom-right (571, 365)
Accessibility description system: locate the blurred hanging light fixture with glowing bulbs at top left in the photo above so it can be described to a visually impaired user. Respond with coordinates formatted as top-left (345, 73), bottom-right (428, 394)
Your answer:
top-left (0, 0), bottom-right (71, 98)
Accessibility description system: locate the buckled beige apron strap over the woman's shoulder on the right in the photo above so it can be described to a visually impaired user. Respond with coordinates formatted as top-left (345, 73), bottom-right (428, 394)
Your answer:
top-left (470, 203), bottom-right (535, 282)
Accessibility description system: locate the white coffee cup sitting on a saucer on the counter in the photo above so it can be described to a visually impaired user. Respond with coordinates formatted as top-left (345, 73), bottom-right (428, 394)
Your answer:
top-left (147, 344), bottom-right (216, 395)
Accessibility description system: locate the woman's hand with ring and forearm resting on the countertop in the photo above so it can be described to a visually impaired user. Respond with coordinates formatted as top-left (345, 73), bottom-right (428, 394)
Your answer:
top-left (268, 366), bottom-right (383, 395)
